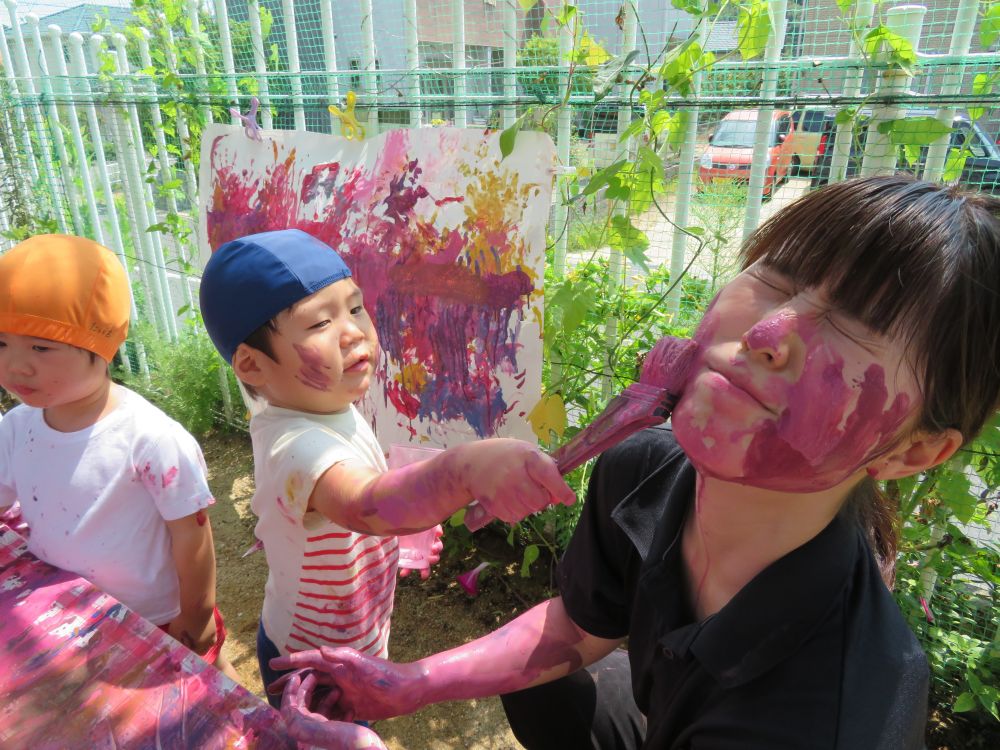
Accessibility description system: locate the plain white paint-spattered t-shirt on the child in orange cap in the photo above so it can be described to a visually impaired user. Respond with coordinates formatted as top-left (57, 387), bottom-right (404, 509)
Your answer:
top-left (0, 386), bottom-right (215, 625)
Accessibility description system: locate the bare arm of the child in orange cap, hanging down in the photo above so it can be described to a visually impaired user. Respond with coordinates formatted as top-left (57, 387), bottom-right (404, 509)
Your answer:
top-left (166, 510), bottom-right (215, 654)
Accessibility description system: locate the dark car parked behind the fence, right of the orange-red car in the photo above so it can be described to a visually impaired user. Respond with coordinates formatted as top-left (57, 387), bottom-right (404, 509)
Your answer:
top-left (812, 109), bottom-right (1000, 195)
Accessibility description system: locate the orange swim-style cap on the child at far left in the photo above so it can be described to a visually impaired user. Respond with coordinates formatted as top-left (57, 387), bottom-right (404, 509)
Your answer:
top-left (0, 234), bottom-right (130, 362)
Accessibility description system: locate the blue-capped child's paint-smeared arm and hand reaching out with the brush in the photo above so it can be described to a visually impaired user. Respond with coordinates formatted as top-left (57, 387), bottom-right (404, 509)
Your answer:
top-left (309, 438), bottom-right (576, 535)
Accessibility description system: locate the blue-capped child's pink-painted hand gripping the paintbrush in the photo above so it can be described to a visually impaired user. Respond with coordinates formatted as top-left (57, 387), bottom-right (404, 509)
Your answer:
top-left (455, 438), bottom-right (576, 523)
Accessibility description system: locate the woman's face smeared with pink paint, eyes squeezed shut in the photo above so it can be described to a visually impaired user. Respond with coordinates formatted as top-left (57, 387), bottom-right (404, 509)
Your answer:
top-left (672, 263), bottom-right (920, 492)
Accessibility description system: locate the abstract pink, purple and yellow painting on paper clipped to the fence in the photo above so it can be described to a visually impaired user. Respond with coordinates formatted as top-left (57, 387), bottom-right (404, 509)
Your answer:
top-left (200, 125), bottom-right (555, 448)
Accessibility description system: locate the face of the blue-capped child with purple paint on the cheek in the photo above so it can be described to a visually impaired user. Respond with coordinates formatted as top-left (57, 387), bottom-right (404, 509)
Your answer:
top-left (261, 278), bottom-right (378, 414)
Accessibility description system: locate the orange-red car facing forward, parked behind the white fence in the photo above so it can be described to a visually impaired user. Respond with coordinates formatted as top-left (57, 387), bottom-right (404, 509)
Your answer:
top-left (698, 109), bottom-right (794, 195)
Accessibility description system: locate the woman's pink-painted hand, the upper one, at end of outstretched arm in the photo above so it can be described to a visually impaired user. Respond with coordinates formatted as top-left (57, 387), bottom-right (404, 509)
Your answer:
top-left (267, 647), bottom-right (423, 721)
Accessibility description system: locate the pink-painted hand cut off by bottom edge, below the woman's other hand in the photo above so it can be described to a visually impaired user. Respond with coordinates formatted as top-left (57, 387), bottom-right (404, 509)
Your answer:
top-left (281, 671), bottom-right (386, 750)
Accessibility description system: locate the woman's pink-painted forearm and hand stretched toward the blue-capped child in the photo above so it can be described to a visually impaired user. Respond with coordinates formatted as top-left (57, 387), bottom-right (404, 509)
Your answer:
top-left (271, 597), bottom-right (624, 739)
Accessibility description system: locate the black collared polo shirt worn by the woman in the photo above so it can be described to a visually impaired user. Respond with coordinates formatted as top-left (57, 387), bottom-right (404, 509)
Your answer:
top-left (559, 427), bottom-right (928, 750)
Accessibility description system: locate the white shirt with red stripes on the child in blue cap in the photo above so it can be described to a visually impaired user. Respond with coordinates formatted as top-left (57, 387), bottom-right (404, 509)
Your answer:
top-left (250, 405), bottom-right (399, 657)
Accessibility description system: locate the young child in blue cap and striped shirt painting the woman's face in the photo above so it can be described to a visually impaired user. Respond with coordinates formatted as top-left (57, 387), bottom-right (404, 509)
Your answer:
top-left (201, 229), bottom-right (575, 705)
